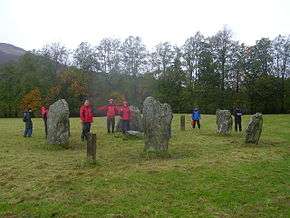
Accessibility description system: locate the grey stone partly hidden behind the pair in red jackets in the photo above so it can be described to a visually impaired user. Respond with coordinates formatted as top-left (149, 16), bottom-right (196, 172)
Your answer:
top-left (116, 106), bottom-right (144, 132)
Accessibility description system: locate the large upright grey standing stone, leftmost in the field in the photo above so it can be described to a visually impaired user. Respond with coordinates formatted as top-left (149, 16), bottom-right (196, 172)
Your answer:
top-left (47, 99), bottom-right (70, 145)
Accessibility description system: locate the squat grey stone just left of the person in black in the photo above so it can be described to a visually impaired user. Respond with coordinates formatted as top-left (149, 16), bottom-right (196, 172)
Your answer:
top-left (216, 110), bottom-right (233, 135)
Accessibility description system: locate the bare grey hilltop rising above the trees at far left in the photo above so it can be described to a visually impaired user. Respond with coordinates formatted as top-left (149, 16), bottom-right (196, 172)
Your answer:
top-left (0, 43), bottom-right (26, 64)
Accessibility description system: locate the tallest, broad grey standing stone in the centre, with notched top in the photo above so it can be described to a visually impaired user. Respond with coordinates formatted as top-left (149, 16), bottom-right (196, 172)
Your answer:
top-left (143, 97), bottom-right (173, 152)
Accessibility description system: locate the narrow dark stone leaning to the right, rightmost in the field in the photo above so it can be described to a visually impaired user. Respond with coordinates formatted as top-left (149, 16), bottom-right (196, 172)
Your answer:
top-left (246, 113), bottom-right (263, 144)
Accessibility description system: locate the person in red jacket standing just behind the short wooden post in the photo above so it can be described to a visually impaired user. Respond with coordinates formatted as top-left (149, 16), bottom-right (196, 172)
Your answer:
top-left (80, 100), bottom-right (94, 141)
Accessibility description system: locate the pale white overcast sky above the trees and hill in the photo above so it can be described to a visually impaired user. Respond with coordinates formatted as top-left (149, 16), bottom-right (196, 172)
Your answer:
top-left (0, 0), bottom-right (290, 50)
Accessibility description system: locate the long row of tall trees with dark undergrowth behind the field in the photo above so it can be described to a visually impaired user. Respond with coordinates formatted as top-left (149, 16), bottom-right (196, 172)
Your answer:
top-left (0, 29), bottom-right (290, 117)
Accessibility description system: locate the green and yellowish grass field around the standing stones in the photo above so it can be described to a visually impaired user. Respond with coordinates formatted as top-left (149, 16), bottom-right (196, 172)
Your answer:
top-left (0, 115), bottom-right (290, 217)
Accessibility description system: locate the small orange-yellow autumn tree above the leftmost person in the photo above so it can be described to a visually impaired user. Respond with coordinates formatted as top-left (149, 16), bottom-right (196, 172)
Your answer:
top-left (20, 88), bottom-right (41, 110)
